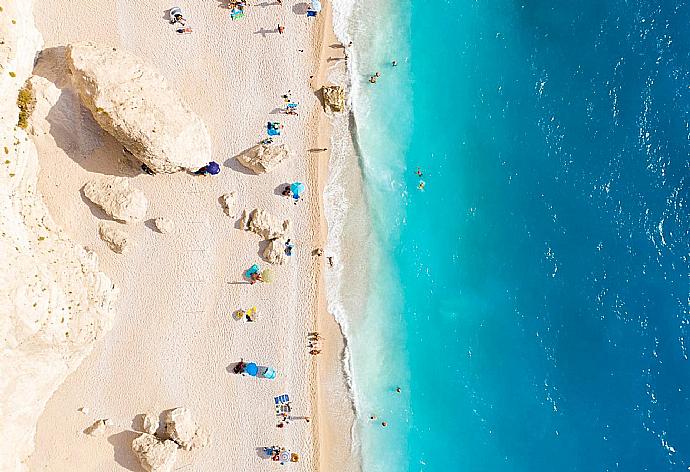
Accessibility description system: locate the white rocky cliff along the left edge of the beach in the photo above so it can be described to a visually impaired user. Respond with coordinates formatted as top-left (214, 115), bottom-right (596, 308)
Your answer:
top-left (0, 0), bottom-right (116, 472)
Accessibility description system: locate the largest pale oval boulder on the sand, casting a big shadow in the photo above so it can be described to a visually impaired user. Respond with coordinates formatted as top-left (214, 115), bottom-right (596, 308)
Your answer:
top-left (67, 43), bottom-right (211, 172)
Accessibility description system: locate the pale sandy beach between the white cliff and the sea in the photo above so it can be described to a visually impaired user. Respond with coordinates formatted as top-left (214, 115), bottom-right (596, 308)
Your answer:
top-left (22, 0), bottom-right (356, 472)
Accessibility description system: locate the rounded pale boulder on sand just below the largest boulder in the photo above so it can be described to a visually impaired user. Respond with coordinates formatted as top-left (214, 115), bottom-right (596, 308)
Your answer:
top-left (84, 176), bottom-right (149, 223)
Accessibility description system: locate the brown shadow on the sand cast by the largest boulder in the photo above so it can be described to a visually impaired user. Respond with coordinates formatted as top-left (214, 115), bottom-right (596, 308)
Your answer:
top-left (33, 46), bottom-right (139, 177)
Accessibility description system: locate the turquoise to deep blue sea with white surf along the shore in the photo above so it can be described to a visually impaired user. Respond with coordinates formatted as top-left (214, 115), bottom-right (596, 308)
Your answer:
top-left (334, 0), bottom-right (690, 472)
